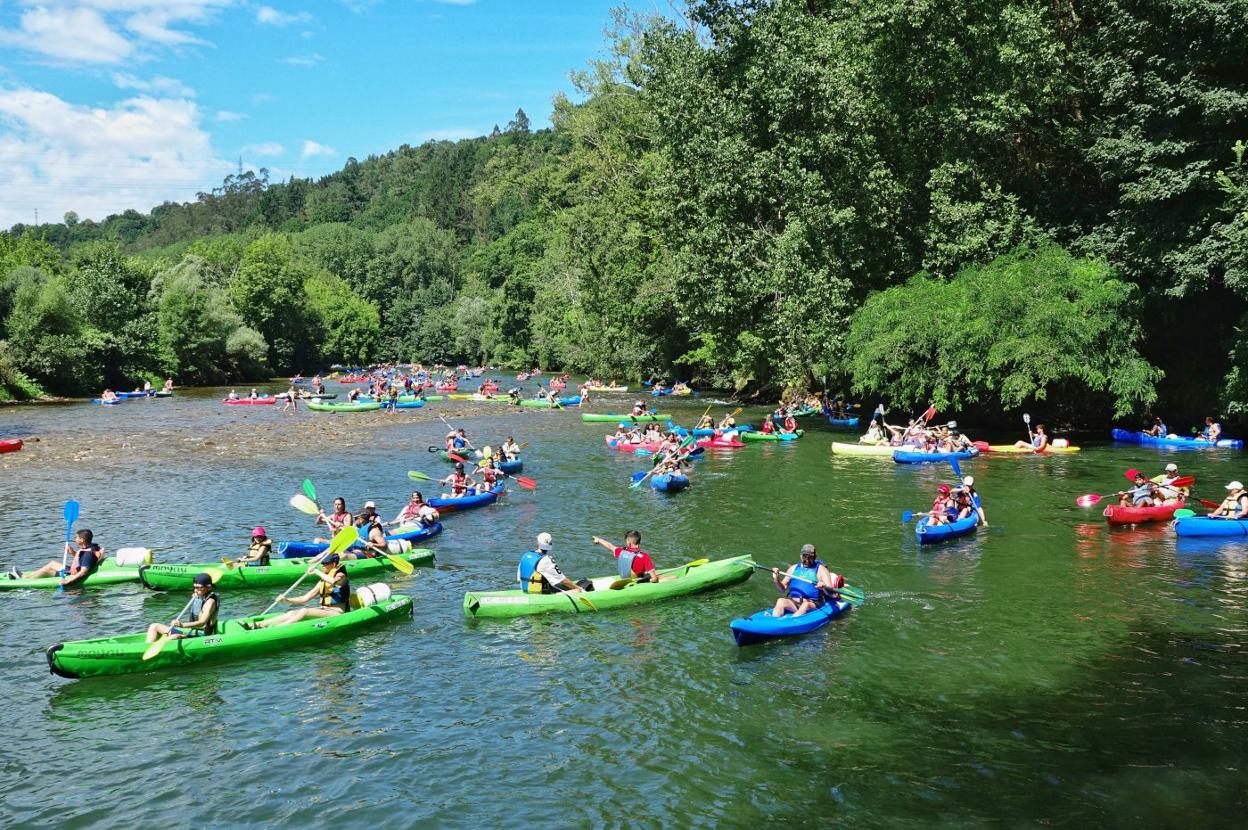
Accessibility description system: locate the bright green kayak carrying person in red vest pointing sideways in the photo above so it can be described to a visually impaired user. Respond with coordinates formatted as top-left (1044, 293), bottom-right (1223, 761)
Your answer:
top-left (464, 555), bottom-right (754, 618)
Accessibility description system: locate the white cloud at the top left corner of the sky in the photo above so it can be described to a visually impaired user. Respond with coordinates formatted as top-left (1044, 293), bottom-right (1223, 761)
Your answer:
top-left (0, 0), bottom-right (233, 64)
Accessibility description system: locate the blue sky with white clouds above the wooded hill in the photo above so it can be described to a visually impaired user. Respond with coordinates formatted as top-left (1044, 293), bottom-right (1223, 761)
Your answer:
top-left (0, 0), bottom-right (656, 227)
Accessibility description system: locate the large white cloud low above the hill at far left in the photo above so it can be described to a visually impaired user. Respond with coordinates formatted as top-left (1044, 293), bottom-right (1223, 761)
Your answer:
top-left (0, 86), bottom-right (231, 227)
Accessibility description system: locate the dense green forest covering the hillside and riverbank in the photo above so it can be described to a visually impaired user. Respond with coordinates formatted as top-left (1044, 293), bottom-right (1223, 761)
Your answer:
top-left (0, 0), bottom-right (1248, 423)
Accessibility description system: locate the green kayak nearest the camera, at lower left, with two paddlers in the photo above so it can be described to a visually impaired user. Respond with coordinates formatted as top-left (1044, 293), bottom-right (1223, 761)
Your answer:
top-left (47, 594), bottom-right (412, 679)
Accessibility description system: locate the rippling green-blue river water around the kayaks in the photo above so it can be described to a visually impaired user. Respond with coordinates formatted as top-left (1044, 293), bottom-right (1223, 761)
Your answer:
top-left (0, 389), bottom-right (1248, 828)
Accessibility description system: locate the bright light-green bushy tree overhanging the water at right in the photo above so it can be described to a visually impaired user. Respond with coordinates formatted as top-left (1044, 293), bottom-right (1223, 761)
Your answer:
top-left (846, 245), bottom-right (1161, 417)
